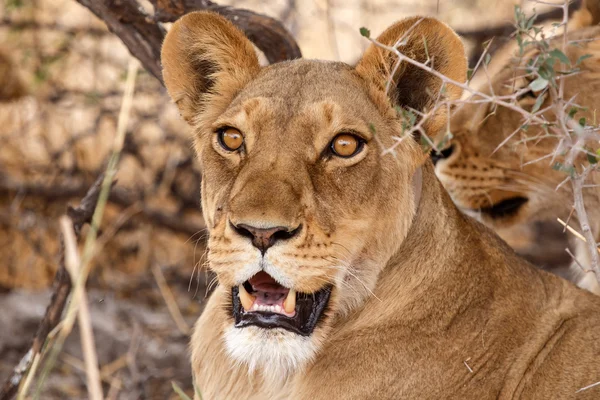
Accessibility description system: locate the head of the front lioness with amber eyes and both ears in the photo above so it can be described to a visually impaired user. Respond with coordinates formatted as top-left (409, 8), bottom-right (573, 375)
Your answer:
top-left (162, 13), bottom-right (466, 375)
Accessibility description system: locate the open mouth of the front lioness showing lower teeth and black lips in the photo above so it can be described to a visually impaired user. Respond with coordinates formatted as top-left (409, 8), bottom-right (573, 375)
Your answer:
top-left (231, 271), bottom-right (331, 336)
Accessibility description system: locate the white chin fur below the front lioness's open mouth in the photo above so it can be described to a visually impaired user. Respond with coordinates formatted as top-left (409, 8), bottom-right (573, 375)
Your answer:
top-left (224, 326), bottom-right (316, 384)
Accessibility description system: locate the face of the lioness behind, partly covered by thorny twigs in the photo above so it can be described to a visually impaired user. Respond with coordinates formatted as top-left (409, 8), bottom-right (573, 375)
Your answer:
top-left (432, 28), bottom-right (600, 261)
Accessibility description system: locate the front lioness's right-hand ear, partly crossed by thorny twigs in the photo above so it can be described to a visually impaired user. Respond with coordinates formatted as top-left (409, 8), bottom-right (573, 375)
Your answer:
top-left (356, 17), bottom-right (467, 135)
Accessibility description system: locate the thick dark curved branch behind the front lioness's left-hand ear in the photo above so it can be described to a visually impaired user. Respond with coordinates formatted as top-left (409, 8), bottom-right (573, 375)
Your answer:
top-left (77, 0), bottom-right (302, 83)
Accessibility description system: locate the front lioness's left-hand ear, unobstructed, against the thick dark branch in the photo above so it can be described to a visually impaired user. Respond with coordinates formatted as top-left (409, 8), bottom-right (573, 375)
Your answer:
top-left (161, 12), bottom-right (260, 124)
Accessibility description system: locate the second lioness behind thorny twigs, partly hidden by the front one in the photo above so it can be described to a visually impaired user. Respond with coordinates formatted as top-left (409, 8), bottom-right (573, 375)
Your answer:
top-left (433, 0), bottom-right (600, 294)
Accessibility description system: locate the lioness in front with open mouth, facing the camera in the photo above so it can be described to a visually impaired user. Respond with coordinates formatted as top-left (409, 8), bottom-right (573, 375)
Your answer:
top-left (162, 12), bottom-right (600, 400)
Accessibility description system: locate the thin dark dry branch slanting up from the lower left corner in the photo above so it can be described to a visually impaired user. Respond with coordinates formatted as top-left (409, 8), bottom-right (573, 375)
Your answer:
top-left (0, 175), bottom-right (104, 400)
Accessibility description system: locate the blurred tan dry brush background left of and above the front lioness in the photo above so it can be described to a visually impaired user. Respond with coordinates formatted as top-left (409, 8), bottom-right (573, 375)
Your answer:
top-left (0, 0), bottom-right (580, 399)
